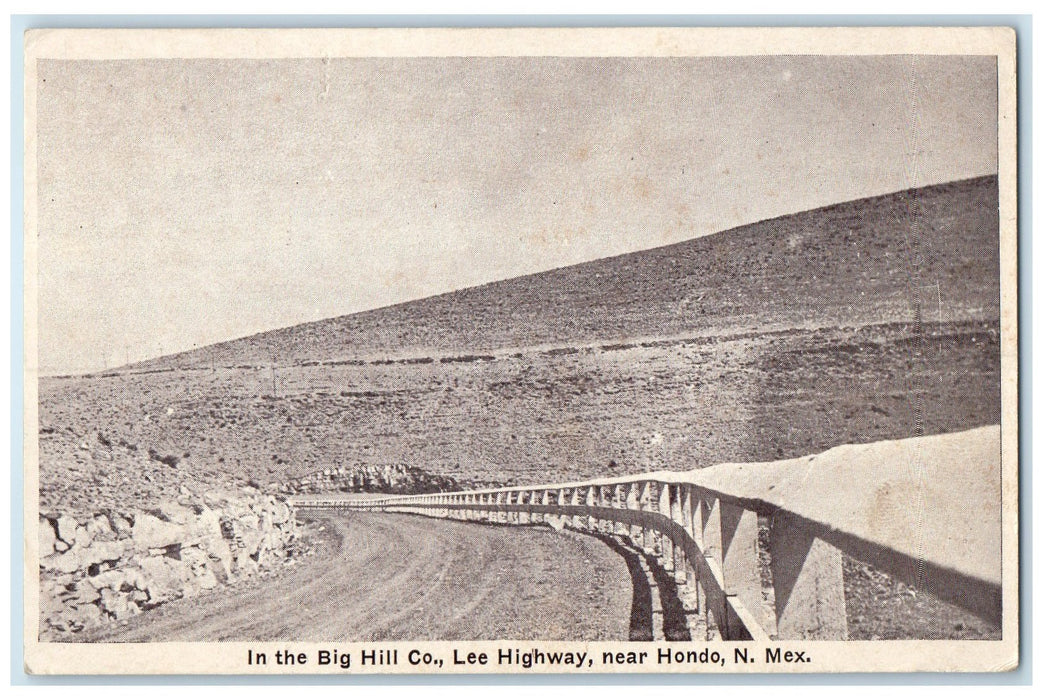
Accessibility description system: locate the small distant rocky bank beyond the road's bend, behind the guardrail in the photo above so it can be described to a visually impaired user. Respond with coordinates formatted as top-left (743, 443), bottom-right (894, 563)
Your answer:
top-left (282, 464), bottom-right (461, 494)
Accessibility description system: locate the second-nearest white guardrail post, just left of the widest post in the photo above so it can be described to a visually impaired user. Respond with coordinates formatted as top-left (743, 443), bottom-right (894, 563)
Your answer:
top-left (721, 503), bottom-right (765, 639)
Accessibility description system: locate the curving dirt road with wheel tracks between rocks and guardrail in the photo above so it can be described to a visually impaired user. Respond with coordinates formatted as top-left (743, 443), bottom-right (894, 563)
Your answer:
top-left (85, 513), bottom-right (633, 642)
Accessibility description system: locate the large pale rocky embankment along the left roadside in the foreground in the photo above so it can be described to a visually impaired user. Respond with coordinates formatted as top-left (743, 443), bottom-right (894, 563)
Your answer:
top-left (40, 489), bottom-right (305, 641)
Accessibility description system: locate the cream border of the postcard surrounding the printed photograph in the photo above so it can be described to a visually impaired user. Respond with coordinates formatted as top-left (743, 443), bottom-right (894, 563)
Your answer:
top-left (23, 27), bottom-right (1019, 675)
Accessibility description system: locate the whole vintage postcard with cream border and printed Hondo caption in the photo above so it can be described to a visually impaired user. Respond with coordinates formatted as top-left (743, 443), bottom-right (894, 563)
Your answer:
top-left (24, 27), bottom-right (1019, 674)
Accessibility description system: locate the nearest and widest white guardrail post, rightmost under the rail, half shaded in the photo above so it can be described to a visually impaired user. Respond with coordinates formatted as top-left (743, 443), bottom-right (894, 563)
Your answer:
top-left (770, 511), bottom-right (848, 639)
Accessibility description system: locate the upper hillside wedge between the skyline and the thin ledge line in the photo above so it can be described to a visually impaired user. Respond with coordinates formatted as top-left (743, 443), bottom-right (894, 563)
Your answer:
top-left (136, 176), bottom-right (999, 368)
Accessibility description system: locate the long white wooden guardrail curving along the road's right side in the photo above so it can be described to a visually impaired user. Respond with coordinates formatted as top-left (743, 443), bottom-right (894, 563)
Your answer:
top-left (293, 426), bottom-right (1001, 641)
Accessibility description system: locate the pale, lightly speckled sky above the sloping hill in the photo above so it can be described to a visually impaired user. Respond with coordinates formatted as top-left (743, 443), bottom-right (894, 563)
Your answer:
top-left (30, 56), bottom-right (997, 373)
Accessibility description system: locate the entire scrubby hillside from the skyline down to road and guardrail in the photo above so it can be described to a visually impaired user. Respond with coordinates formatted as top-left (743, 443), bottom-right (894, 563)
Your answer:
top-left (40, 177), bottom-right (1000, 511)
